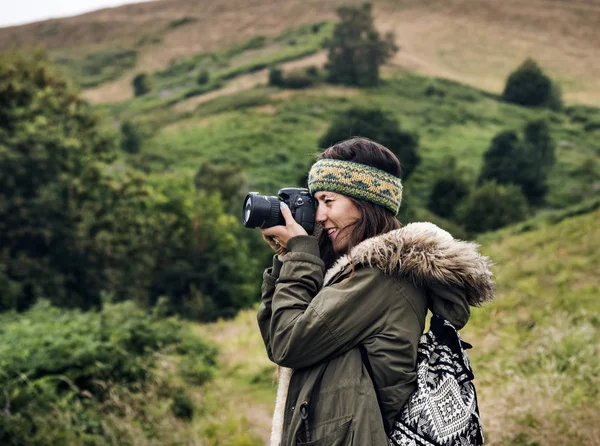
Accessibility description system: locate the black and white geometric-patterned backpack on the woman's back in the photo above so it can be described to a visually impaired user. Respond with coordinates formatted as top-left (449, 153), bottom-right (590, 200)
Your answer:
top-left (361, 315), bottom-right (483, 446)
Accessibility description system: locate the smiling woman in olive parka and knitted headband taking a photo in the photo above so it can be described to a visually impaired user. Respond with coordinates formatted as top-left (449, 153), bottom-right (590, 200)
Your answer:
top-left (258, 138), bottom-right (493, 446)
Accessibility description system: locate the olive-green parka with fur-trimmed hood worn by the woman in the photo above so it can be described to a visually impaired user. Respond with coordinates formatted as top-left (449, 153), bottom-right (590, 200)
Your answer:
top-left (258, 223), bottom-right (493, 446)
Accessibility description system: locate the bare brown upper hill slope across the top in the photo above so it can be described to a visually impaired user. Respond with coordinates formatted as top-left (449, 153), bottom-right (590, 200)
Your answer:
top-left (0, 0), bottom-right (600, 105)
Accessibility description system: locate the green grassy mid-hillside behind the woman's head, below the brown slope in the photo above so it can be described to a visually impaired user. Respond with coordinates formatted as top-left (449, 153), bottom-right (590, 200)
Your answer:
top-left (132, 75), bottom-right (600, 214)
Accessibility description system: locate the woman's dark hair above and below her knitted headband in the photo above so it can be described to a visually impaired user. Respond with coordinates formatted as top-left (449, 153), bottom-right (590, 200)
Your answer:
top-left (318, 137), bottom-right (401, 268)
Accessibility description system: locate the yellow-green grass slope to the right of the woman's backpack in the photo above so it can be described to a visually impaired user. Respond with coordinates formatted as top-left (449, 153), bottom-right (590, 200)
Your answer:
top-left (464, 209), bottom-right (600, 445)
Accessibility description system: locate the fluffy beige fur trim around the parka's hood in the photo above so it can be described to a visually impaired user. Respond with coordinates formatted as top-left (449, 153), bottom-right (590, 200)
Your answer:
top-left (324, 223), bottom-right (494, 306)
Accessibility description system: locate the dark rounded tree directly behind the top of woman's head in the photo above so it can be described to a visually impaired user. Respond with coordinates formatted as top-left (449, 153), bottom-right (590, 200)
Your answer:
top-left (319, 107), bottom-right (421, 180)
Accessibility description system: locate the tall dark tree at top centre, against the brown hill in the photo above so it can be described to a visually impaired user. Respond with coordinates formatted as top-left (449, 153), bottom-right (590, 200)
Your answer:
top-left (325, 3), bottom-right (398, 87)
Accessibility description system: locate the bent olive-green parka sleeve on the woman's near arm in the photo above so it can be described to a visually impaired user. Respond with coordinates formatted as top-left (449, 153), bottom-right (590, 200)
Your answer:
top-left (263, 236), bottom-right (395, 368)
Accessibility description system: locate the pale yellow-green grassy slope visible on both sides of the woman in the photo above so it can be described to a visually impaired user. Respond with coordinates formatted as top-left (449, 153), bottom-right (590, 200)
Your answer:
top-left (198, 205), bottom-right (600, 446)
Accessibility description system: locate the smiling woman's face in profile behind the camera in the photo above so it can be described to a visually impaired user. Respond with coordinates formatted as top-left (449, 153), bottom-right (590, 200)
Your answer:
top-left (315, 191), bottom-right (360, 254)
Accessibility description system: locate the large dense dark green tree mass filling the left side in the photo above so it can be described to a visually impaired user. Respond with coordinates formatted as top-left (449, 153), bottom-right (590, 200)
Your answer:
top-left (0, 51), bottom-right (258, 320)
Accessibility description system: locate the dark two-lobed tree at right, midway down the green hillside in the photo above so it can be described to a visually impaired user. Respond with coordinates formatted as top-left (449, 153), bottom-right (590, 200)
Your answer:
top-left (479, 120), bottom-right (556, 205)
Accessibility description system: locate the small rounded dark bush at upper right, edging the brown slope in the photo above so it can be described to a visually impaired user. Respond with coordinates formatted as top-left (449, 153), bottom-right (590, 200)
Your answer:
top-left (502, 59), bottom-right (562, 110)
